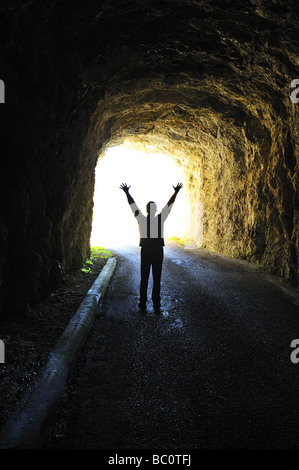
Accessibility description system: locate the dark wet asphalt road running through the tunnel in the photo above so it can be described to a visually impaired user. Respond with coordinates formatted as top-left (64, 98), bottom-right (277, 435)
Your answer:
top-left (45, 245), bottom-right (299, 449)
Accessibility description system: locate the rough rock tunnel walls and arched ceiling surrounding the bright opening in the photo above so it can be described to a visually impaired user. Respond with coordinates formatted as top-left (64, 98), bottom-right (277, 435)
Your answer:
top-left (0, 0), bottom-right (299, 316)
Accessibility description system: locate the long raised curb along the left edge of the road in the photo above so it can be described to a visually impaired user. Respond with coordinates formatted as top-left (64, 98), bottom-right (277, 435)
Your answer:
top-left (0, 258), bottom-right (116, 449)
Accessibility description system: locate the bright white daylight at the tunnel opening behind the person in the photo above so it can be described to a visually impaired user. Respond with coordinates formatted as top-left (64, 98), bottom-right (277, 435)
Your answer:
top-left (91, 146), bottom-right (185, 248)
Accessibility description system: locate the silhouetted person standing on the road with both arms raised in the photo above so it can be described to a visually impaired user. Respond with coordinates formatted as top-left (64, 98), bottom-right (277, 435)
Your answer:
top-left (120, 183), bottom-right (183, 310)
